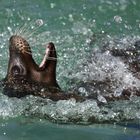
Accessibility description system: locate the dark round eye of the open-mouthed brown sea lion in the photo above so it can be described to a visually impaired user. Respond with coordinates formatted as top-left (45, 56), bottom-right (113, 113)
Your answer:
top-left (11, 65), bottom-right (23, 76)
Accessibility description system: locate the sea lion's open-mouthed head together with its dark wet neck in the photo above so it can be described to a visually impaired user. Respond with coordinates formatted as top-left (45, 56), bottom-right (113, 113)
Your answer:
top-left (3, 35), bottom-right (84, 101)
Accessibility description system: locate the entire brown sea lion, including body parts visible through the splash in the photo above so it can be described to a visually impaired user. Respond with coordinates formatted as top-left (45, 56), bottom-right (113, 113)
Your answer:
top-left (3, 35), bottom-right (140, 102)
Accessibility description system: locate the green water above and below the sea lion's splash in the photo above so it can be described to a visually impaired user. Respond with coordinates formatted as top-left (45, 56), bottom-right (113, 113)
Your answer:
top-left (0, 0), bottom-right (140, 140)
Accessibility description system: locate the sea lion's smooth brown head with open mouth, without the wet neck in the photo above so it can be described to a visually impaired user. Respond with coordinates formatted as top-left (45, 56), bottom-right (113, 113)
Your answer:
top-left (6, 36), bottom-right (59, 88)
